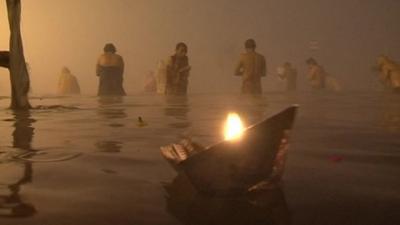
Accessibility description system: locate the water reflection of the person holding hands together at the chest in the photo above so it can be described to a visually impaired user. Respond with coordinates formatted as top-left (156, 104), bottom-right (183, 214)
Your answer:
top-left (164, 96), bottom-right (191, 129)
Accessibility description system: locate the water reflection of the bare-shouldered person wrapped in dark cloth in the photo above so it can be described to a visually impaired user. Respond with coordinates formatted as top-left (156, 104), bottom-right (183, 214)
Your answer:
top-left (95, 96), bottom-right (128, 153)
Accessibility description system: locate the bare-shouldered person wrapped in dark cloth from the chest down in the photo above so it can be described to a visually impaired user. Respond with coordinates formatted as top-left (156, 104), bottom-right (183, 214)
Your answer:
top-left (96, 43), bottom-right (126, 96)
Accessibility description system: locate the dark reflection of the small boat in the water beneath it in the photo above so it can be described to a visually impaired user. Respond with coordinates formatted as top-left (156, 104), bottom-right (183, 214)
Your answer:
top-left (165, 174), bottom-right (291, 225)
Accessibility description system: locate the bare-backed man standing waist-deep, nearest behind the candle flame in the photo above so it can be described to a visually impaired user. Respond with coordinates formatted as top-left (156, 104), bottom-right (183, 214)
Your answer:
top-left (235, 39), bottom-right (267, 94)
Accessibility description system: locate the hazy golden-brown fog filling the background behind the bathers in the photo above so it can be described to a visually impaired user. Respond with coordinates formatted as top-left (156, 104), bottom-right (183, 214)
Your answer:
top-left (0, 0), bottom-right (400, 95)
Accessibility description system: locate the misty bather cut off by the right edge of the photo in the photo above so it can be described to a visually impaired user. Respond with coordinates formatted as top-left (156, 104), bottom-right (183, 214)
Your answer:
top-left (378, 55), bottom-right (400, 93)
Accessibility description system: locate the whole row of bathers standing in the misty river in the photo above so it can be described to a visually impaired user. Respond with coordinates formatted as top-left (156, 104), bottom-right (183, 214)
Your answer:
top-left (53, 39), bottom-right (400, 96)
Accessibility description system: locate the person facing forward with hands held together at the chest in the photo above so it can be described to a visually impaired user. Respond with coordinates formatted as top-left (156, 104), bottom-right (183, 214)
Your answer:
top-left (165, 42), bottom-right (191, 95)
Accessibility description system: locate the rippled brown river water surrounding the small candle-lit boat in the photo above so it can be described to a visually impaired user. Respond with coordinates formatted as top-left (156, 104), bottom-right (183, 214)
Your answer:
top-left (0, 93), bottom-right (400, 225)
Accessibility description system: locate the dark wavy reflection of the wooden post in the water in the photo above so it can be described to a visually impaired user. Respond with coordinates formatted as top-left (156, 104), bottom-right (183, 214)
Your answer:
top-left (0, 111), bottom-right (36, 217)
